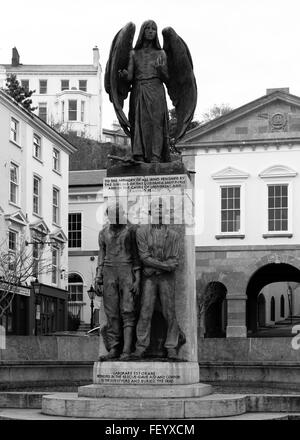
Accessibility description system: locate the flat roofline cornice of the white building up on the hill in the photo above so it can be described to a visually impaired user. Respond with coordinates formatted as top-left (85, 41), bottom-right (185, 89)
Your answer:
top-left (0, 64), bottom-right (98, 74)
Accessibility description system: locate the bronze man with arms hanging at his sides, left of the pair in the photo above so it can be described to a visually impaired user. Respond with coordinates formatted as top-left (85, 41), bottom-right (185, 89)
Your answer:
top-left (96, 205), bottom-right (140, 360)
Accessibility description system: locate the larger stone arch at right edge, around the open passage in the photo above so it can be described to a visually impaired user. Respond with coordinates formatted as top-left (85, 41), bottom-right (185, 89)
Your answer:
top-left (246, 262), bottom-right (300, 333)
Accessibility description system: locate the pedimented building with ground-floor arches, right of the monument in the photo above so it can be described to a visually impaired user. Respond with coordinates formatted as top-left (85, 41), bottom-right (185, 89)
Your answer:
top-left (180, 89), bottom-right (300, 337)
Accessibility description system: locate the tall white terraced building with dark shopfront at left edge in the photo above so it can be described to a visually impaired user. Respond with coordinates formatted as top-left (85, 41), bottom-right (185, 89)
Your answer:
top-left (0, 91), bottom-right (75, 335)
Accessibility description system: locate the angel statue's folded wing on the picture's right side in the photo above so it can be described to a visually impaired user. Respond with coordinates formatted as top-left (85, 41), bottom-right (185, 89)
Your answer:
top-left (162, 27), bottom-right (197, 142)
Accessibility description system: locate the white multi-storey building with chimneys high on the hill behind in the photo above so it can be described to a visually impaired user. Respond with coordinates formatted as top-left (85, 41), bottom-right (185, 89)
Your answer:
top-left (0, 47), bottom-right (102, 141)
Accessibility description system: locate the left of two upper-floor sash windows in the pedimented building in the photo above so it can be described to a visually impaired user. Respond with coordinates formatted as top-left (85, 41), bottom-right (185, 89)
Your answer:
top-left (221, 186), bottom-right (241, 232)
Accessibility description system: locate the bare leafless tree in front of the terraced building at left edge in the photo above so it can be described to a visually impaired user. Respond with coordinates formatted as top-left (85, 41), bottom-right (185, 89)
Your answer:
top-left (0, 239), bottom-right (52, 320)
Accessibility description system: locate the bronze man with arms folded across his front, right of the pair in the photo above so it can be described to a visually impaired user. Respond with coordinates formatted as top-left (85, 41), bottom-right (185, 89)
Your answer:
top-left (132, 207), bottom-right (185, 359)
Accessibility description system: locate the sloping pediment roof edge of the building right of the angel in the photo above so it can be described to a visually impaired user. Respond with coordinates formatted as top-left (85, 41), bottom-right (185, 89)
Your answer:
top-left (177, 90), bottom-right (300, 148)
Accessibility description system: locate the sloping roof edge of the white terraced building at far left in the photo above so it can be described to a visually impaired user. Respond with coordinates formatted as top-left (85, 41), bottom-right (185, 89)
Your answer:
top-left (0, 89), bottom-right (77, 153)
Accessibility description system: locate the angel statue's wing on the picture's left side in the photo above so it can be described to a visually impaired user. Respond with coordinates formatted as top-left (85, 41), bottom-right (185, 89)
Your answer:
top-left (104, 22), bottom-right (135, 136)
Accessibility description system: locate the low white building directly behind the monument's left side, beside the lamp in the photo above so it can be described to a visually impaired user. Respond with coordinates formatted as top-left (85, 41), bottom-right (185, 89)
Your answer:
top-left (68, 170), bottom-right (106, 324)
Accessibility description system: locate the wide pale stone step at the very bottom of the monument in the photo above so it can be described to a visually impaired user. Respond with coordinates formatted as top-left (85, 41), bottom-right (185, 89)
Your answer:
top-left (42, 393), bottom-right (246, 419)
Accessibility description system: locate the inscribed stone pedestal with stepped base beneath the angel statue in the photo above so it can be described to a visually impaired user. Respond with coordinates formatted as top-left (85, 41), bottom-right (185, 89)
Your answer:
top-left (43, 161), bottom-right (216, 419)
